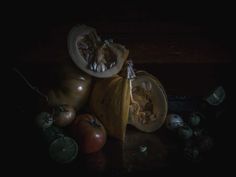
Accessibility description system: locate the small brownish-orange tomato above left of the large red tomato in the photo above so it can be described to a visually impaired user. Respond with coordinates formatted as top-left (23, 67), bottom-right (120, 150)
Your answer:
top-left (53, 105), bottom-right (76, 127)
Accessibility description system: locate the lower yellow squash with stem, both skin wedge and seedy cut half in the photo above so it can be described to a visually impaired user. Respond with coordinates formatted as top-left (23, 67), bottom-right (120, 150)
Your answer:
top-left (90, 61), bottom-right (168, 141)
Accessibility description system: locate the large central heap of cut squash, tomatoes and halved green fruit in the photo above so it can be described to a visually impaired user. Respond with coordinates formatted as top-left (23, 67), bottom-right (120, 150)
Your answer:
top-left (36, 25), bottom-right (167, 163)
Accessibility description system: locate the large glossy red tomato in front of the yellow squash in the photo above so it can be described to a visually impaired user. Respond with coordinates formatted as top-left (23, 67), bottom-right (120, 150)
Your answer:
top-left (71, 114), bottom-right (106, 154)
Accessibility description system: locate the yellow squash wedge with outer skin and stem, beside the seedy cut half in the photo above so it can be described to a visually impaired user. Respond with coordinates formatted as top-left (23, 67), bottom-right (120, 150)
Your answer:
top-left (90, 61), bottom-right (132, 141)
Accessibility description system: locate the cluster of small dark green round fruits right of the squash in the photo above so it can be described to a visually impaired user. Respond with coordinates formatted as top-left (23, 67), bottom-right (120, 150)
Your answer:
top-left (166, 112), bottom-right (213, 162)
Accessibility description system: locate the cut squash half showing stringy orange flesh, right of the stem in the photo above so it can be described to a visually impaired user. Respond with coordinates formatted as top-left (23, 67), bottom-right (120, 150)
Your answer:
top-left (128, 71), bottom-right (168, 133)
